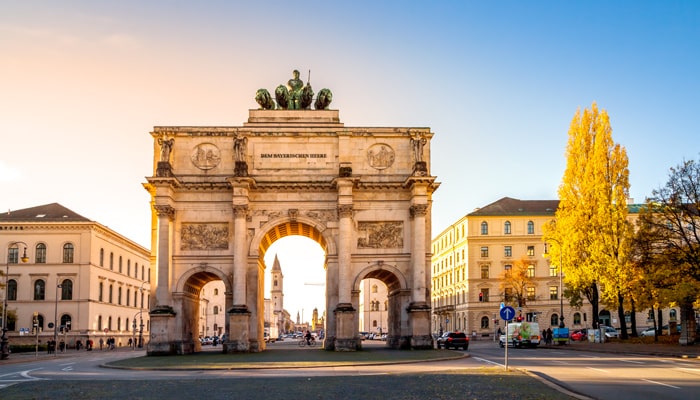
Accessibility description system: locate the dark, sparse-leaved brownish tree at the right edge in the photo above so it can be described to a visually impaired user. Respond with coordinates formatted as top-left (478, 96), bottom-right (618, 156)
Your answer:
top-left (639, 160), bottom-right (700, 344)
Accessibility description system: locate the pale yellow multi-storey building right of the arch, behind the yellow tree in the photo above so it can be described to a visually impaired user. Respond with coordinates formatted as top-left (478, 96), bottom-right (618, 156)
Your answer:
top-left (431, 197), bottom-right (680, 338)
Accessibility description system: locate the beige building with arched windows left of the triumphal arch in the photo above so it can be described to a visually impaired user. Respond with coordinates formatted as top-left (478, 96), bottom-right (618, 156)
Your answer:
top-left (0, 203), bottom-right (151, 347)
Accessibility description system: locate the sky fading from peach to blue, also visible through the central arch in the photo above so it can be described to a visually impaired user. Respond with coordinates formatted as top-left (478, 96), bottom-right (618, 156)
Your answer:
top-left (0, 0), bottom-right (700, 317)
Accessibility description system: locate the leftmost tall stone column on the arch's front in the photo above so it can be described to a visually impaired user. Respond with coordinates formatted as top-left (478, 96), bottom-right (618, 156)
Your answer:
top-left (154, 205), bottom-right (175, 308)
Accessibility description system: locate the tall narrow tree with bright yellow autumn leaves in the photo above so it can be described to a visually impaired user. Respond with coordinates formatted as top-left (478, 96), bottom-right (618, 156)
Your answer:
top-left (544, 103), bottom-right (632, 338)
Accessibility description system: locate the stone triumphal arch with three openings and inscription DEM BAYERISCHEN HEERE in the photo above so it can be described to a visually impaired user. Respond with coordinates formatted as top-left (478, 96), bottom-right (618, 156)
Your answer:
top-left (144, 72), bottom-right (439, 355)
